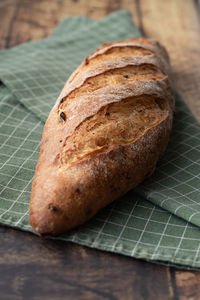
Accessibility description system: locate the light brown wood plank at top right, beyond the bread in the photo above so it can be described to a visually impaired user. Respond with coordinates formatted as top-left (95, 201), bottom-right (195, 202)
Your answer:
top-left (139, 0), bottom-right (200, 121)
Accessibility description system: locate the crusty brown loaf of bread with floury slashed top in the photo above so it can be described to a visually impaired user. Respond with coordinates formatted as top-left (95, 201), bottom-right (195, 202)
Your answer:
top-left (29, 38), bottom-right (174, 236)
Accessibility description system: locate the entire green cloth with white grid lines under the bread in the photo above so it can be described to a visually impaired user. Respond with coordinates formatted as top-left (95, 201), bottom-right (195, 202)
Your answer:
top-left (0, 10), bottom-right (200, 269)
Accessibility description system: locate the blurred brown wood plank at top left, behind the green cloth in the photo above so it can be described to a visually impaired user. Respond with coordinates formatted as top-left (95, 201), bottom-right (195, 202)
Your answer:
top-left (0, 0), bottom-right (138, 48)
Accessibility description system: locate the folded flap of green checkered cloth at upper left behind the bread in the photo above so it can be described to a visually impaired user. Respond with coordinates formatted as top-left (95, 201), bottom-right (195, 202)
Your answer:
top-left (0, 12), bottom-right (139, 121)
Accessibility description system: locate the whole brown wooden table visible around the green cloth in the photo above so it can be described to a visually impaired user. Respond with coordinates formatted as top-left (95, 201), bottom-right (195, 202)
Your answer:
top-left (0, 0), bottom-right (200, 300)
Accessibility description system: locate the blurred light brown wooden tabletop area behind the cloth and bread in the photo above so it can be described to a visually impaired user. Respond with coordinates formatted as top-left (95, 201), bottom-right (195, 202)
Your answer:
top-left (0, 0), bottom-right (200, 121)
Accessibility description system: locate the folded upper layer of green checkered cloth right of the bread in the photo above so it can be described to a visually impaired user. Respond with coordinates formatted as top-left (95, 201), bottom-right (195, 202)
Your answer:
top-left (136, 92), bottom-right (200, 226)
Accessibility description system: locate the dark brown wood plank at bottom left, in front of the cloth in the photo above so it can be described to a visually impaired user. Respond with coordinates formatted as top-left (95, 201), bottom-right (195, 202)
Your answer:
top-left (0, 227), bottom-right (175, 300)
